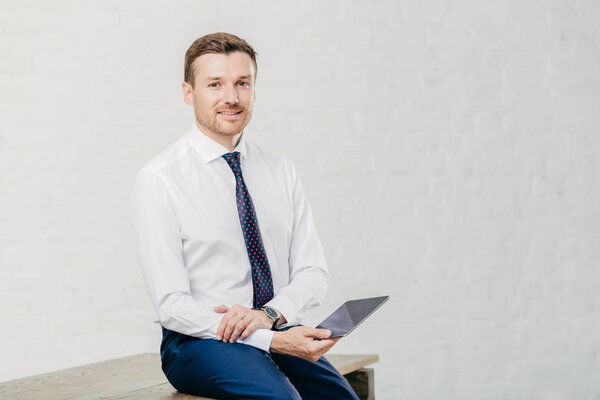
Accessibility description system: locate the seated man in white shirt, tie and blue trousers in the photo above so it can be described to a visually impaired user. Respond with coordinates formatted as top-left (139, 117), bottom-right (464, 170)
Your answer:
top-left (131, 33), bottom-right (357, 399)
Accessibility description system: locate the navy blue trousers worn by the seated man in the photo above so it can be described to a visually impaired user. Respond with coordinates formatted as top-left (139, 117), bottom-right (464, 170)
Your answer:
top-left (160, 328), bottom-right (358, 400)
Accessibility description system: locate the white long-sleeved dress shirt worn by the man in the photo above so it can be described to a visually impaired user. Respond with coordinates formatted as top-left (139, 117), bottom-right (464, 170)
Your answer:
top-left (131, 124), bottom-right (328, 351)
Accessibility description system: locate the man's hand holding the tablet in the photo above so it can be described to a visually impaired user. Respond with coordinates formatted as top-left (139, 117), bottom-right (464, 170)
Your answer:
top-left (271, 326), bottom-right (341, 361)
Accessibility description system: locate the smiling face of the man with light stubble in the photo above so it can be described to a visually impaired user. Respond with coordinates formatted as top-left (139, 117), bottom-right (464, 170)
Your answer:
top-left (183, 52), bottom-right (256, 143)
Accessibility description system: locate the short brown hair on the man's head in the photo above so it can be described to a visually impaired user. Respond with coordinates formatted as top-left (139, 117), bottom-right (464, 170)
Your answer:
top-left (183, 32), bottom-right (257, 87)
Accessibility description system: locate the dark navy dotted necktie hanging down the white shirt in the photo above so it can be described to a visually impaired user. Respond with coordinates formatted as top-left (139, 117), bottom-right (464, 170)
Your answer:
top-left (223, 151), bottom-right (273, 308)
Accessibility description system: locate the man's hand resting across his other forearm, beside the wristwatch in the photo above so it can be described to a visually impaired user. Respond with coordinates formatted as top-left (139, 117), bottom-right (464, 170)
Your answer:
top-left (213, 304), bottom-right (273, 343)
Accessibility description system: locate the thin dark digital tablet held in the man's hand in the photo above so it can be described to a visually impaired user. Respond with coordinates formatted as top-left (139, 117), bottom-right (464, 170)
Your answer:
top-left (317, 296), bottom-right (390, 337)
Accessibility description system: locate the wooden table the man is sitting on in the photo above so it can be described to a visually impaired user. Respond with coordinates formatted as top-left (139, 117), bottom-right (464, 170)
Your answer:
top-left (0, 354), bottom-right (379, 400)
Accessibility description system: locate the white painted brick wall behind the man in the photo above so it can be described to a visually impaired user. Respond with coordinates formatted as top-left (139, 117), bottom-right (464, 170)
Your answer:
top-left (0, 0), bottom-right (600, 400)
